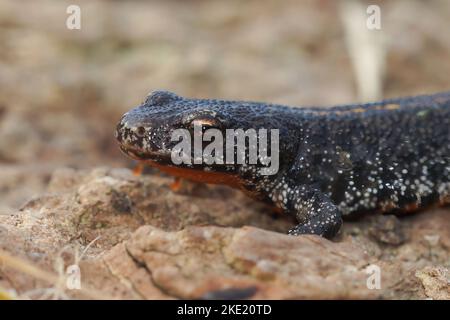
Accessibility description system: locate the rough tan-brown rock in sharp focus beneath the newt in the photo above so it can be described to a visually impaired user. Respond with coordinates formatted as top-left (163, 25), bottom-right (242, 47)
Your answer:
top-left (0, 168), bottom-right (450, 299)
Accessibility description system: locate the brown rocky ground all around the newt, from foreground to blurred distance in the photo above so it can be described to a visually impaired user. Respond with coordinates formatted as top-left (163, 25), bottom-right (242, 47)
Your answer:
top-left (0, 0), bottom-right (450, 299)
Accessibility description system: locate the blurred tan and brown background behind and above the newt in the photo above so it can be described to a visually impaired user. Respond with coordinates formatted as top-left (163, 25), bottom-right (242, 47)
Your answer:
top-left (0, 0), bottom-right (450, 214)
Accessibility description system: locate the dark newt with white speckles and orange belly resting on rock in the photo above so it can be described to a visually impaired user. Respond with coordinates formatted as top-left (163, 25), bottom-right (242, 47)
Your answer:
top-left (115, 91), bottom-right (450, 238)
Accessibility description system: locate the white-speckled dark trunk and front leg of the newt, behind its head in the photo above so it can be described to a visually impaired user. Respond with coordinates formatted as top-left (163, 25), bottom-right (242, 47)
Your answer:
top-left (246, 92), bottom-right (450, 237)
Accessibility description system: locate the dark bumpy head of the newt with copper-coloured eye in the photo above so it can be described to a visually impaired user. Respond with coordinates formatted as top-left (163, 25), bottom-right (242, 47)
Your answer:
top-left (116, 91), bottom-right (296, 182)
